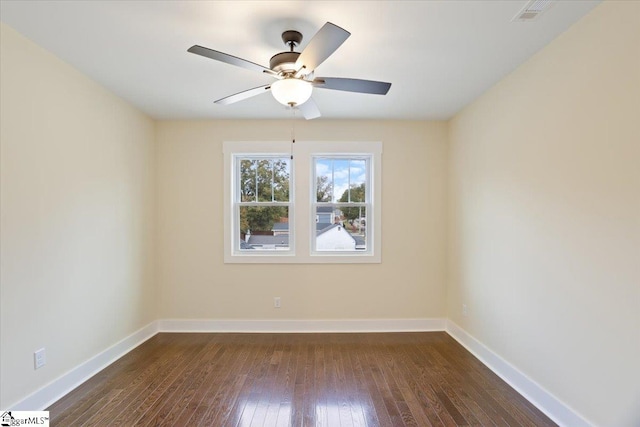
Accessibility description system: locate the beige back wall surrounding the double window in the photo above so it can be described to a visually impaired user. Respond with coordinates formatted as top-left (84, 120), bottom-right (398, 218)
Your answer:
top-left (157, 120), bottom-right (446, 319)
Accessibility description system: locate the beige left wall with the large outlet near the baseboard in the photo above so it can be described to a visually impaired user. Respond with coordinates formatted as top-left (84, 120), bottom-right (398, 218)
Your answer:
top-left (0, 24), bottom-right (156, 409)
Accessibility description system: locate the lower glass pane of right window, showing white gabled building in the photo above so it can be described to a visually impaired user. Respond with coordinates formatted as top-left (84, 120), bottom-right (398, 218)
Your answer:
top-left (315, 206), bottom-right (367, 251)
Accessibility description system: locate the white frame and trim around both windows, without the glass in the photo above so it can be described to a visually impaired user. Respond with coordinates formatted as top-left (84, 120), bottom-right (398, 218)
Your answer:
top-left (223, 140), bottom-right (382, 264)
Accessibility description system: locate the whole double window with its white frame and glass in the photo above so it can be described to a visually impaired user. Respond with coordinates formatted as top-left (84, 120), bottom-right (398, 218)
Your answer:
top-left (224, 141), bottom-right (382, 263)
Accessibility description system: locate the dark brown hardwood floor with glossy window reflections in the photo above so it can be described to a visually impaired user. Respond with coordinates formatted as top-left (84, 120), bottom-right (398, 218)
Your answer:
top-left (48, 332), bottom-right (555, 427)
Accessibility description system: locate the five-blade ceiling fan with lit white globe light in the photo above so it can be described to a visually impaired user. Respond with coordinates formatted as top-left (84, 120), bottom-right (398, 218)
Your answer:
top-left (187, 22), bottom-right (391, 120)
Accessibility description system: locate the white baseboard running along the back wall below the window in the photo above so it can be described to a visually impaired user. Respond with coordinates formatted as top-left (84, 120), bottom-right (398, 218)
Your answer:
top-left (158, 318), bottom-right (446, 333)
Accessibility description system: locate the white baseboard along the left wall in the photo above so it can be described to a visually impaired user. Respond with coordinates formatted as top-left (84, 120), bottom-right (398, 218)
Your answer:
top-left (5, 321), bottom-right (158, 411)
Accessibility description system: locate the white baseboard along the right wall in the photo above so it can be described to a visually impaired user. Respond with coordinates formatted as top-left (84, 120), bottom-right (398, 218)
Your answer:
top-left (446, 320), bottom-right (592, 427)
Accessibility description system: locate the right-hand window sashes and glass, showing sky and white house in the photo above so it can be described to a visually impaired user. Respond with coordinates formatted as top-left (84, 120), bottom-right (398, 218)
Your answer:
top-left (311, 154), bottom-right (372, 254)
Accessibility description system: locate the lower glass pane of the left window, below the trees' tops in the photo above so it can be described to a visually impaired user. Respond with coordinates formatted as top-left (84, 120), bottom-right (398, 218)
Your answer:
top-left (240, 206), bottom-right (289, 250)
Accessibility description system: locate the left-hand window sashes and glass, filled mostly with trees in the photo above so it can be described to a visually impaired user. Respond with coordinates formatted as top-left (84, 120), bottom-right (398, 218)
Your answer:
top-left (234, 154), bottom-right (293, 255)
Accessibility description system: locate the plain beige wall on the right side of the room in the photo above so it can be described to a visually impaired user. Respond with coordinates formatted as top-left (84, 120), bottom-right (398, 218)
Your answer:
top-left (448, 2), bottom-right (640, 426)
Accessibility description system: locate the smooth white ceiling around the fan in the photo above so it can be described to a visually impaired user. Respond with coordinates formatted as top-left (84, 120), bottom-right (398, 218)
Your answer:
top-left (0, 0), bottom-right (599, 120)
